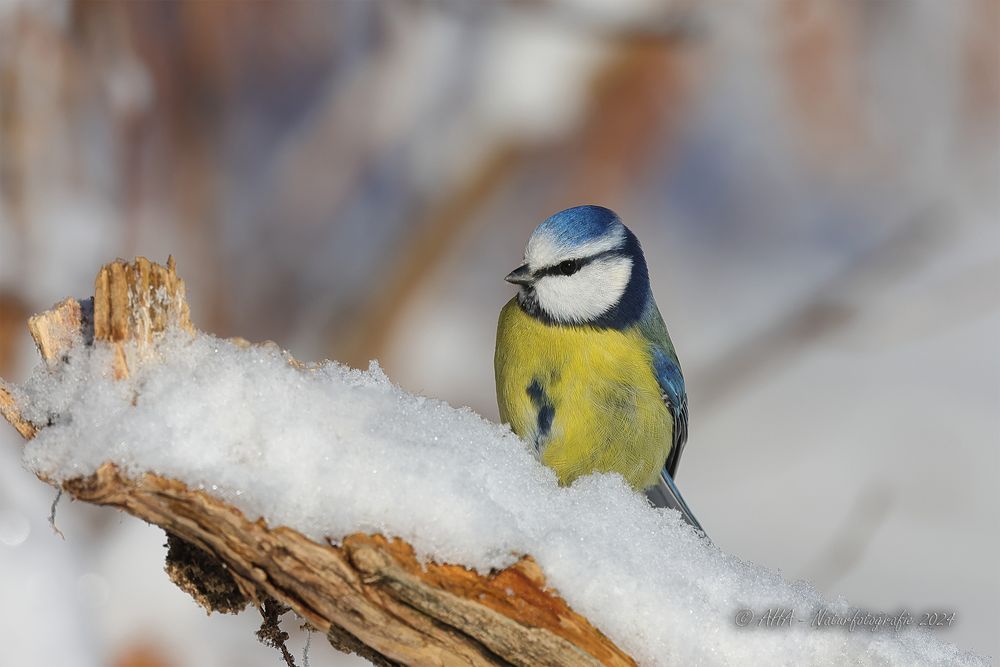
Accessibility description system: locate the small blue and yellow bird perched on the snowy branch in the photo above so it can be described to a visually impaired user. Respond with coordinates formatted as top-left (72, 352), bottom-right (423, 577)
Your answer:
top-left (494, 205), bottom-right (704, 534)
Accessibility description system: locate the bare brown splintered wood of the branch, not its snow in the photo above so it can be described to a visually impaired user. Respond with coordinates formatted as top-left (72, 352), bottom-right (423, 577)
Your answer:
top-left (0, 258), bottom-right (635, 666)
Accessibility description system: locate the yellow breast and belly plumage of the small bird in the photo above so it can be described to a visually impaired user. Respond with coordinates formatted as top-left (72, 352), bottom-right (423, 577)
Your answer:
top-left (494, 299), bottom-right (673, 489)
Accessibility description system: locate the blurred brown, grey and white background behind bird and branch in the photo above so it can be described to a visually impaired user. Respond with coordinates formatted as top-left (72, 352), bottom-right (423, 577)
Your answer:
top-left (0, 0), bottom-right (1000, 667)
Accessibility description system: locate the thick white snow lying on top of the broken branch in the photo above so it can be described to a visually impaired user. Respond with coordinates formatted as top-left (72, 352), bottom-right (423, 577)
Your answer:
top-left (6, 332), bottom-right (987, 665)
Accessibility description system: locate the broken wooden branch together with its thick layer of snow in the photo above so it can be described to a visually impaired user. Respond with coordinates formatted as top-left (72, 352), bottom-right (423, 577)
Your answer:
top-left (0, 259), bottom-right (987, 667)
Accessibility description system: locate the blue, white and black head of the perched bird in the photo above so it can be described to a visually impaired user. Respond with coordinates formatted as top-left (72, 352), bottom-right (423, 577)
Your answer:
top-left (505, 206), bottom-right (649, 327)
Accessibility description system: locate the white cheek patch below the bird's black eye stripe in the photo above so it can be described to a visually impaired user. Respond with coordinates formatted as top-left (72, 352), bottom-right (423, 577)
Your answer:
top-left (535, 257), bottom-right (632, 323)
